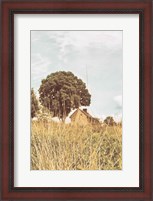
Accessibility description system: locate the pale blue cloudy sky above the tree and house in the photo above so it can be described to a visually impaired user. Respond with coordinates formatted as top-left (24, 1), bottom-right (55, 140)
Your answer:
top-left (31, 31), bottom-right (123, 118)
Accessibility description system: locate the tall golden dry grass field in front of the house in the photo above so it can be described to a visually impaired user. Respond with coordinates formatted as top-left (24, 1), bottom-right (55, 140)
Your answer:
top-left (31, 122), bottom-right (122, 170)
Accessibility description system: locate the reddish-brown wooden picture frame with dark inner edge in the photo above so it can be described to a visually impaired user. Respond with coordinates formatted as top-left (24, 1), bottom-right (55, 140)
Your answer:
top-left (1, 0), bottom-right (153, 201)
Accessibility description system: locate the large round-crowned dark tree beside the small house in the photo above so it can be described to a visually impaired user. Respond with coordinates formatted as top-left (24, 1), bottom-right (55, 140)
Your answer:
top-left (39, 71), bottom-right (91, 121)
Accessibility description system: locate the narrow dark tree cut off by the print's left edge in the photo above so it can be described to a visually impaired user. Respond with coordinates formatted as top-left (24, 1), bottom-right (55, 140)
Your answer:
top-left (31, 89), bottom-right (39, 118)
